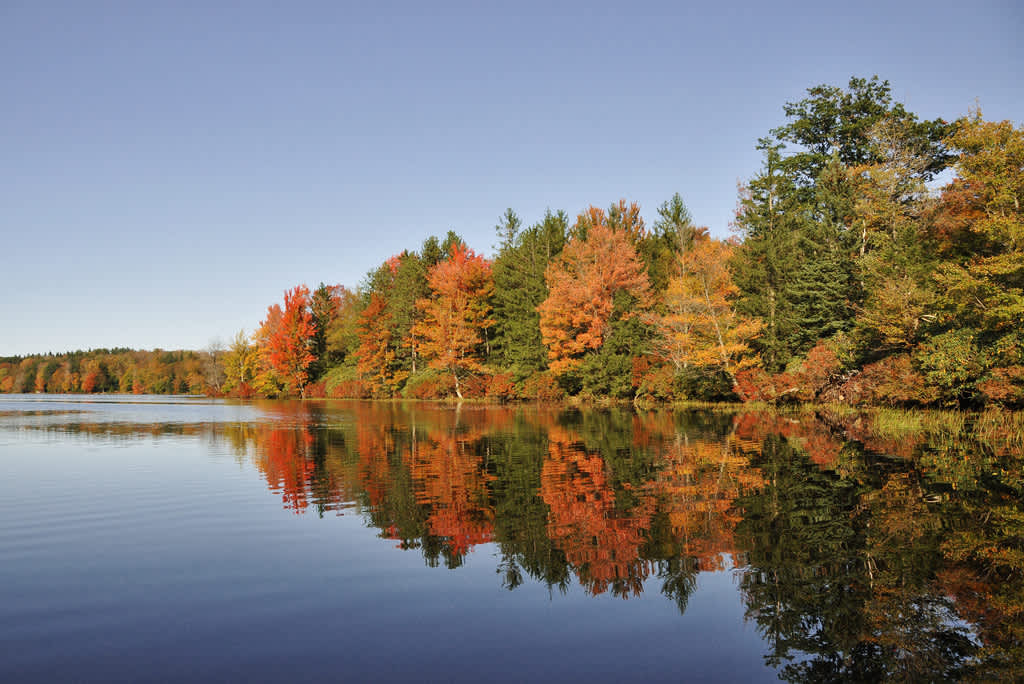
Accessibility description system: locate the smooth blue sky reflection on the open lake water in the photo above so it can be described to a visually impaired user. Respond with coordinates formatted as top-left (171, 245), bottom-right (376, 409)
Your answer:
top-left (0, 417), bottom-right (775, 681)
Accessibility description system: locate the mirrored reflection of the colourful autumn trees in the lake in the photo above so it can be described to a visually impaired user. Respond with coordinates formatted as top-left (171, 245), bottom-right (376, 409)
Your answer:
top-left (18, 402), bottom-right (1024, 681)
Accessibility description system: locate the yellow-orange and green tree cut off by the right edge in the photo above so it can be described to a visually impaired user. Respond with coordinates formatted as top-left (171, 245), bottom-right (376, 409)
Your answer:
top-left (919, 112), bottom-right (1024, 403)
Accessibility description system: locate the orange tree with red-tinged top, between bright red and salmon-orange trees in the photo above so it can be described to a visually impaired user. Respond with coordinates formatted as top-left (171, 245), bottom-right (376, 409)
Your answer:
top-left (413, 245), bottom-right (495, 399)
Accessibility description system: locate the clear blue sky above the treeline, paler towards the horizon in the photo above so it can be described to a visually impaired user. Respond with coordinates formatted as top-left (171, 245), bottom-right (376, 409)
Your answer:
top-left (0, 0), bottom-right (1024, 355)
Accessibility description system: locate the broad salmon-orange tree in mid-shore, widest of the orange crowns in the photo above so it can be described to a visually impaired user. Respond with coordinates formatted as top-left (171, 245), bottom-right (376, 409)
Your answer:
top-left (538, 207), bottom-right (650, 375)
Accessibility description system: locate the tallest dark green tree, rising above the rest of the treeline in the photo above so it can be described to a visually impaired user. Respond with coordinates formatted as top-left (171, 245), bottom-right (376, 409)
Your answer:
top-left (735, 77), bottom-right (950, 370)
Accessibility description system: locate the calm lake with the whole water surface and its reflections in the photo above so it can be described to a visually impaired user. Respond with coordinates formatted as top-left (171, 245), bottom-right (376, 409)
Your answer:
top-left (0, 395), bottom-right (1024, 682)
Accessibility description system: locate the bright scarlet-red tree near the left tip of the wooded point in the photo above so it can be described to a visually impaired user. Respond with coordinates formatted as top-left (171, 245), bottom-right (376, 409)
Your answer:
top-left (256, 285), bottom-right (316, 397)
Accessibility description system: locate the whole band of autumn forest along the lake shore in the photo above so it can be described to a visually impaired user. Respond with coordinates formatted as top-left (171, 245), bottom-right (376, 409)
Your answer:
top-left (0, 77), bottom-right (1024, 408)
